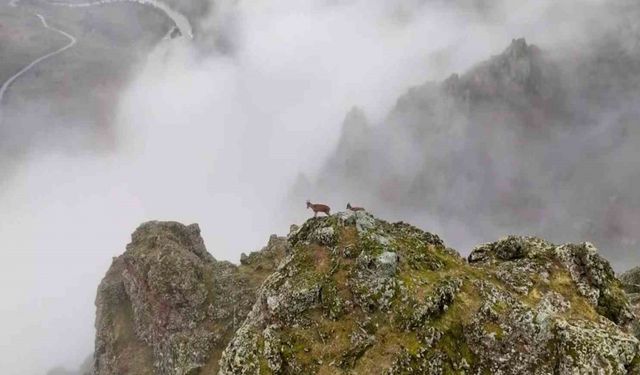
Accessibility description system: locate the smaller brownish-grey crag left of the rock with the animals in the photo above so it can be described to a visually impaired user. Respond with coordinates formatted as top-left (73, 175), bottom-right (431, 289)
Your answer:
top-left (94, 222), bottom-right (287, 375)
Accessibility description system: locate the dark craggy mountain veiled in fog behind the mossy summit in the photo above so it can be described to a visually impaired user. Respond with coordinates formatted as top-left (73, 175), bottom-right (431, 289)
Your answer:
top-left (290, 11), bottom-right (640, 264)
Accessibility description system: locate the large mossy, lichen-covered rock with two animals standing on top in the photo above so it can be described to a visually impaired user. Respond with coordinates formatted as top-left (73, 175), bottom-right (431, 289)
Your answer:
top-left (219, 212), bottom-right (640, 375)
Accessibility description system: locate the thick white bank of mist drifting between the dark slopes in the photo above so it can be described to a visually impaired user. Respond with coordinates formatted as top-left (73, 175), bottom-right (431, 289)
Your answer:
top-left (0, 0), bottom-right (632, 375)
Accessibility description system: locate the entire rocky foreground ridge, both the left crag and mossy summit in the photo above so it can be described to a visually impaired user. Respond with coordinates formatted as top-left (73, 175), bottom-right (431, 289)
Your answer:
top-left (95, 212), bottom-right (640, 375)
